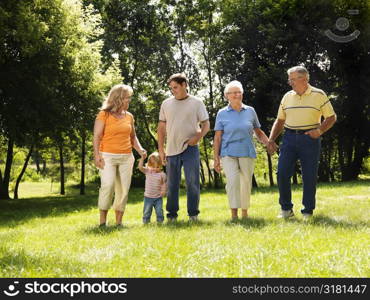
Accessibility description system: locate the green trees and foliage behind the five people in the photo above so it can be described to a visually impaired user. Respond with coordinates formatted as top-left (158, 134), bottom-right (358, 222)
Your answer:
top-left (0, 0), bottom-right (370, 198)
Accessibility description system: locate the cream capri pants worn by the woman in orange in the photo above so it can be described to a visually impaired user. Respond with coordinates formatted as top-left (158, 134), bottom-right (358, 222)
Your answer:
top-left (98, 153), bottom-right (135, 211)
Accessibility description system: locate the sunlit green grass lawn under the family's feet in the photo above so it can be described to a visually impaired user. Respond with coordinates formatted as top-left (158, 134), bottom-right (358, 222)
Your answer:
top-left (0, 180), bottom-right (370, 277)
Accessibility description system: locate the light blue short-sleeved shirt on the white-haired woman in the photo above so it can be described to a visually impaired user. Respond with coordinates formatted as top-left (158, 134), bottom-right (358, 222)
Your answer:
top-left (215, 104), bottom-right (261, 158)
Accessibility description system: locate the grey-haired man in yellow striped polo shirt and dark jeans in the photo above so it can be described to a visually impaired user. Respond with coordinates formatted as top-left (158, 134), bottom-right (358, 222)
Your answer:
top-left (269, 66), bottom-right (336, 219)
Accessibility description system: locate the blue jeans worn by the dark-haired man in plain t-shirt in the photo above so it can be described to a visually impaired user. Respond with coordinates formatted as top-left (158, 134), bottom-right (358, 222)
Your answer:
top-left (166, 146), bottom-right (200, 218)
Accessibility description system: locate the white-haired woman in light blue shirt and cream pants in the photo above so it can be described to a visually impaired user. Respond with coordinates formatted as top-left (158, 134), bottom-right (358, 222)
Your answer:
top-left (213, 81), bottom-right (274, 220)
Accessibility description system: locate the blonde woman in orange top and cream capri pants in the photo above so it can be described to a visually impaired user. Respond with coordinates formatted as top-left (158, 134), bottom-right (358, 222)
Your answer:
top-left (94, 84), bottom-right (146, 227)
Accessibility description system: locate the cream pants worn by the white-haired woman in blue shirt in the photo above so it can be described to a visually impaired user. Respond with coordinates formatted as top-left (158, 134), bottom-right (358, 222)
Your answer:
top-left (221, 156), bottom-right (255, 209)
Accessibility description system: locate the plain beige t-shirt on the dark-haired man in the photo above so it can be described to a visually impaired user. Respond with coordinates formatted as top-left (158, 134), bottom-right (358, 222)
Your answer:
top-left (159, 95), bottom-right (209, 156)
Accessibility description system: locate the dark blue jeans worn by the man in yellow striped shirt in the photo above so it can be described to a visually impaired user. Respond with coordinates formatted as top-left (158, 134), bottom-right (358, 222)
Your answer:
top-left (277, 132), bottom-right (321, 214)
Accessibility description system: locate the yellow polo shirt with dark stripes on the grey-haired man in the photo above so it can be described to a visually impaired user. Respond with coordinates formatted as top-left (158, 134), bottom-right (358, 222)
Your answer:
top-left (277, 85), bottom-right (335, 130)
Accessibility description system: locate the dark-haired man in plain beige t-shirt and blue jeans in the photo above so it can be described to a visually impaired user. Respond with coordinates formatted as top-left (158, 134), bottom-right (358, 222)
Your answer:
top-left (157, 74), bottom-right (210, 221)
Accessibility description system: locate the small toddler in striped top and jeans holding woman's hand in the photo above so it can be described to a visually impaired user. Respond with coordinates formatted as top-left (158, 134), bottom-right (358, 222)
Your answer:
top-left (138, 152), bottom-right (166, 224)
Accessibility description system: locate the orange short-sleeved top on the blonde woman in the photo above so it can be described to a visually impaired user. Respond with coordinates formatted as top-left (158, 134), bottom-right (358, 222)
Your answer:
top-left (96, 110), bottom-right (134, 154)
